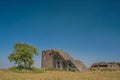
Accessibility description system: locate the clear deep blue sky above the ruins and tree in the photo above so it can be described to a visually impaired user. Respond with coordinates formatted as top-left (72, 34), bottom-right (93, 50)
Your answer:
top-left (0, 0), bottom-right (120, 68)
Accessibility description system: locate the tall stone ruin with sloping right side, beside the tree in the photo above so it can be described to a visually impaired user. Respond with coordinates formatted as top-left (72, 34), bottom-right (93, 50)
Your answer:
top-left (41, 49), bottom-right (88, 72)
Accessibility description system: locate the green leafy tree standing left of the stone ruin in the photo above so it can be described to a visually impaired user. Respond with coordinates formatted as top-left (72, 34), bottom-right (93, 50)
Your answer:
top-left (8, 42), bottom-right (38, 69)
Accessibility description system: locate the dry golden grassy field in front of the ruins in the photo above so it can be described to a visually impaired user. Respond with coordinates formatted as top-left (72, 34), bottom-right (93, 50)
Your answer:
top-left (0, 70), bottom-right (120, 80)
